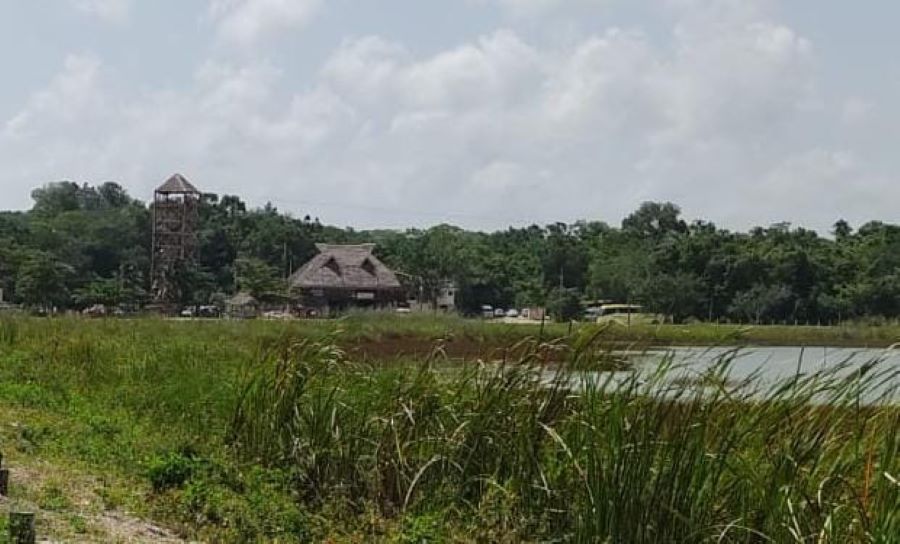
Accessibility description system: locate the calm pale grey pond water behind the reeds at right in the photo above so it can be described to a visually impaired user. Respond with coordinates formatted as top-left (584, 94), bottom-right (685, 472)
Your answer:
top-left (548, 347), bottom-right (900, 403)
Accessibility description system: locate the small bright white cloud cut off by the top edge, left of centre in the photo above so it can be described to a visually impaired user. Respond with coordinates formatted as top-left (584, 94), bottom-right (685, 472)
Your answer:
top-left (209, 0), bottom-right (322, 46)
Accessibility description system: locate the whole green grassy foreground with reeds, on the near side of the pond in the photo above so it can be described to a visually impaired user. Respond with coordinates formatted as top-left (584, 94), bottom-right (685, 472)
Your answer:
top-left (0, 317), bottom-right (900, 543)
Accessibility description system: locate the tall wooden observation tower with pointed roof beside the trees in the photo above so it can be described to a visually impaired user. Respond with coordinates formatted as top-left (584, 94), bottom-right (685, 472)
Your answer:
top-left (151, 174), bottom-right (201, 309)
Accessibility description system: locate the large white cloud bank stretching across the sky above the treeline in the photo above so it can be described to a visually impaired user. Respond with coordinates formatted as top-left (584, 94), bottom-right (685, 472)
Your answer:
top-left (0, 0), bottom-right (890, 228)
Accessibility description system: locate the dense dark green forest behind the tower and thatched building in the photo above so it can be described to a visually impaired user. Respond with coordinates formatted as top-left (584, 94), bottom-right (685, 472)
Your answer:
top-left (0, 178), bottom-right (900, 322)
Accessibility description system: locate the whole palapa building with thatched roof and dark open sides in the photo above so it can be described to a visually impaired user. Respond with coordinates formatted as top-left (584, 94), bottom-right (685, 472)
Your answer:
top-left (289, 244), bottom-right (403, 315)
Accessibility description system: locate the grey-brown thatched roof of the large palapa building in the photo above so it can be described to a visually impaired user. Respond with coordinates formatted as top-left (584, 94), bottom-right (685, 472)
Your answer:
top-left (290, 244), bottom-right (401, 291)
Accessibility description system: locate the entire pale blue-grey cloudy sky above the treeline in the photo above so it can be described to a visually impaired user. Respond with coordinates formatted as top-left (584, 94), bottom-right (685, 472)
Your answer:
top-left (0, 0), bottom-right (900, 232)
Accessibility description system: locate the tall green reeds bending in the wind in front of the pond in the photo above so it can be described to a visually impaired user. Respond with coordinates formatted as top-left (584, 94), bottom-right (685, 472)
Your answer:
top-left (231, 334), bottom-right (900, 543)
